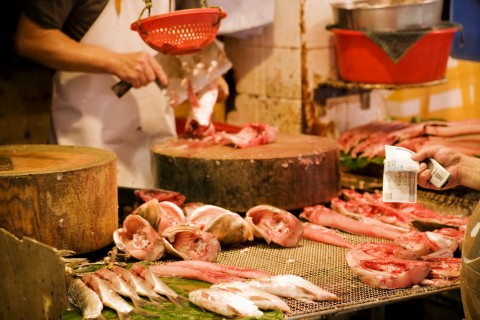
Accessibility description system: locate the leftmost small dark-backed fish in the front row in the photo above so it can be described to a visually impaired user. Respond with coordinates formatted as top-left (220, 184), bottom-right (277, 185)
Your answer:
top-left (67, 279), bottom-right (105, 320)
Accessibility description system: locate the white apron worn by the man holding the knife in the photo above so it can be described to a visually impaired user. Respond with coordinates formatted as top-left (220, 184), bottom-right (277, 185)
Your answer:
top-left (52, 0), bottom-right (176, 188)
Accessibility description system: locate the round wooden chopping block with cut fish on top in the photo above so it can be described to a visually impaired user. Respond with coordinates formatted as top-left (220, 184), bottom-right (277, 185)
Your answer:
top-left (151, 134), bottom-right (340, 212)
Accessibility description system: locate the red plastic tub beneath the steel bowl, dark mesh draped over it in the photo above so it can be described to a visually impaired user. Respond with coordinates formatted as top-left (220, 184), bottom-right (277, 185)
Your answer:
top-left (331, 27), bottom-right (459, 85)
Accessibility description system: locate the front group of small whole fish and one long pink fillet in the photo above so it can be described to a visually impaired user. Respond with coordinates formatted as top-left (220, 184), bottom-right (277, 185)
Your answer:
top-left (68, 261), bottom-right (339, 319)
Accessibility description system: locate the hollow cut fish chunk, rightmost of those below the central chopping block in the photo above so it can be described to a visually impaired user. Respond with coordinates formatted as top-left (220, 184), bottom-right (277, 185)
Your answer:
top-left (245, 205), bottom-right (303, 248)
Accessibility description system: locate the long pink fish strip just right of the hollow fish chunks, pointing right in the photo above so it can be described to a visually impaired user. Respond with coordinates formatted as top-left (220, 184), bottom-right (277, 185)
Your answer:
top-left (300, 205), bottom-right (403, 240)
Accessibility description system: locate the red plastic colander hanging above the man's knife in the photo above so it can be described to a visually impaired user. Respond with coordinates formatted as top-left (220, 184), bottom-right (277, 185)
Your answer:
top-left (131, 1), bottom-right (227, 55)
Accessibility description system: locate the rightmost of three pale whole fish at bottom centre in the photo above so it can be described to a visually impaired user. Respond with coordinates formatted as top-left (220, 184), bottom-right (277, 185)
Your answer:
top-left (246, 274), bottom-right (340, 302)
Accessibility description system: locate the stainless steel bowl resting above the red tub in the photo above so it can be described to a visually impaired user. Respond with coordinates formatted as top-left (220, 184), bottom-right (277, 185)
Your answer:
top-left (331, 0), bottom-right (443, 32)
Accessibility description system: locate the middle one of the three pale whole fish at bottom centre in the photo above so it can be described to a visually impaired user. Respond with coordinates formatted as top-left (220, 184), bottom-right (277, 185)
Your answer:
top-left (210, 281), bottom-right (292, 312)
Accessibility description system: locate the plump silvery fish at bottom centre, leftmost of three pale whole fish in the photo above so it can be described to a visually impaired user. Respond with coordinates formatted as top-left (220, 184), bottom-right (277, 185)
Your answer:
top-left (188, 288), bottom-right (263, 318)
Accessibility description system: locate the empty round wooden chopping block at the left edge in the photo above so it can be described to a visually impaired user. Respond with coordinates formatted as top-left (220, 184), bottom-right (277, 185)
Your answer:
top-left (0, 145), bottom-right (118, 253)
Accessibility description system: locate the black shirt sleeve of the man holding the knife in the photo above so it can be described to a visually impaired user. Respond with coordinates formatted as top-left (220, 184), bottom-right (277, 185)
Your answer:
top-left (22, 0), bottom-right (108, 41)
